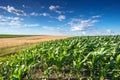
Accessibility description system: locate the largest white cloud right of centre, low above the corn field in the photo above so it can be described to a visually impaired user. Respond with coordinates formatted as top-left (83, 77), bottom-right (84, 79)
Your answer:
top-left (68, 18), bottom-right (99, 31)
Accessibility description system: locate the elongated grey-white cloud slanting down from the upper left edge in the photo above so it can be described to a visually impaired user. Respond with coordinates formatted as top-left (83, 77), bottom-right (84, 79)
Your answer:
top-left (0, 5), bottom-right (26, 16)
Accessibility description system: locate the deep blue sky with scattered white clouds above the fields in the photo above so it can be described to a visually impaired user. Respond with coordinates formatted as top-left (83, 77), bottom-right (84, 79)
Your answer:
top-left (0, 0), bottom-right (120, 35)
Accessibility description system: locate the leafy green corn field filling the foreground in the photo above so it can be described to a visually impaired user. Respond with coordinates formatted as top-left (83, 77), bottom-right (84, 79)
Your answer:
top-left (0, 36), bottom-right (120, 80)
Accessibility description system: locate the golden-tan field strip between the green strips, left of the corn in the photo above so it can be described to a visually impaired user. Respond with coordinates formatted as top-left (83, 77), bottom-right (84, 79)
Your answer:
top-left (0, 36), bottom-right (68, 48)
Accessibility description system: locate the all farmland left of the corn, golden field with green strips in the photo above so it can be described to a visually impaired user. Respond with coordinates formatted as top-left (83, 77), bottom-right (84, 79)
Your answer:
top-left (0, 34), bottom-right (68, 57)
